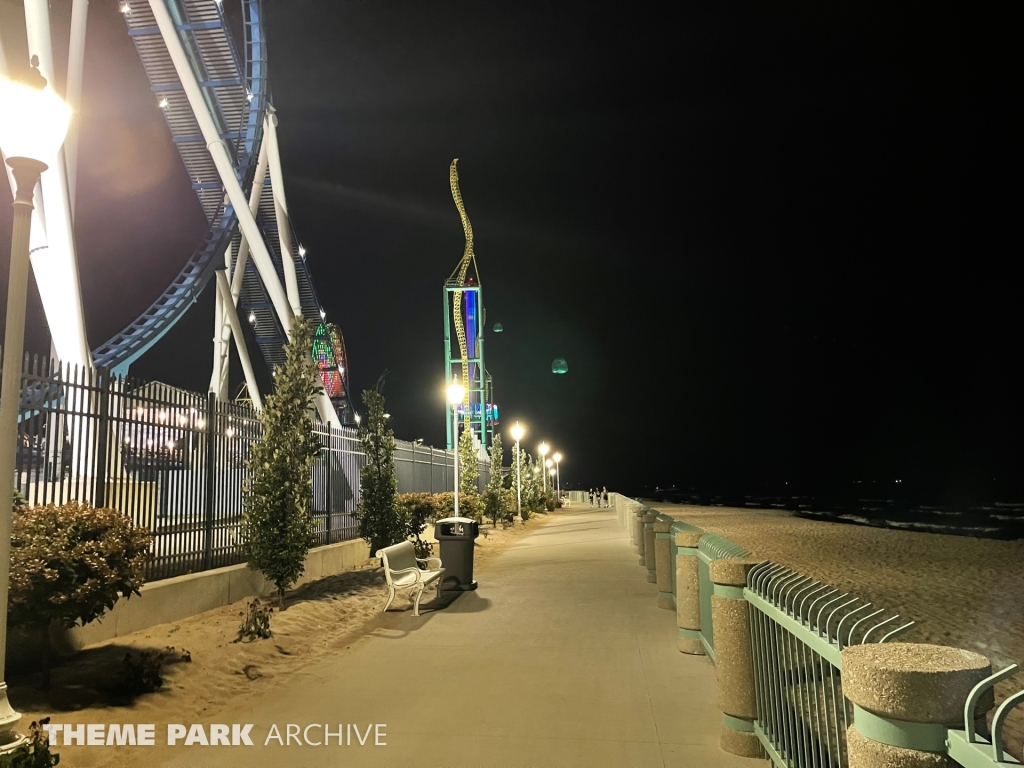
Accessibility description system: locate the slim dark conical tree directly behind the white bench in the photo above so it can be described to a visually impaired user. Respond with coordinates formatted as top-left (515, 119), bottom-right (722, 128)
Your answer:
top-left (355, 389), bottom-right (406, 553)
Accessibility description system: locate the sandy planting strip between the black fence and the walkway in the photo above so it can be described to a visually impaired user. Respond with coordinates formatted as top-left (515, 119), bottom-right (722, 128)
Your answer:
top-left (9, 515), bottom-right (549, 768)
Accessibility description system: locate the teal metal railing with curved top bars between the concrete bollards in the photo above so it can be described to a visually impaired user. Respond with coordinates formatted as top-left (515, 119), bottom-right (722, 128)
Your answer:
top-left (614, 495), bottom-right (1024, 768)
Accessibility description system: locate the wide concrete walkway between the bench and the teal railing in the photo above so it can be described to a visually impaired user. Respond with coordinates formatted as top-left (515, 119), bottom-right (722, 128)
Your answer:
top-left (161, 509), bottom-right (765, 768)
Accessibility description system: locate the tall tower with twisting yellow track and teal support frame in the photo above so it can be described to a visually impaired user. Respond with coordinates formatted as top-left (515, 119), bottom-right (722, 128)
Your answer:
top-left (444, 158), bottom-right (498, 450)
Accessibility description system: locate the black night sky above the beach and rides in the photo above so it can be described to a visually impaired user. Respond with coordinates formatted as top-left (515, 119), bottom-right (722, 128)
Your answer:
top-left (0, 0), bottom-right (1024, 503)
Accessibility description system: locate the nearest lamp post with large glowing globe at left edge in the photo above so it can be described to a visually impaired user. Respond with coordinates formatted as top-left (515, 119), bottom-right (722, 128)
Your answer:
top-left (0, 68), bottom-right (71, 753)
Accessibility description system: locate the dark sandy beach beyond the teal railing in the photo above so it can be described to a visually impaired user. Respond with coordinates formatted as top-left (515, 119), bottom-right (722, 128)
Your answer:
top-left (651, 503), bottom-right (1024, 759)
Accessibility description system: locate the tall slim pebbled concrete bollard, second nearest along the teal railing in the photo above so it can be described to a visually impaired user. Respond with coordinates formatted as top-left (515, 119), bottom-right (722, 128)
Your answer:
top-left (709, 557), bottom-right (765, 768)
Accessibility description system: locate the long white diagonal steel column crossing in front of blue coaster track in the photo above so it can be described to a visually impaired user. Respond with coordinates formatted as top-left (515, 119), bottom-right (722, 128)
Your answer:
top-left (150, 0), bottom-right (295, 336)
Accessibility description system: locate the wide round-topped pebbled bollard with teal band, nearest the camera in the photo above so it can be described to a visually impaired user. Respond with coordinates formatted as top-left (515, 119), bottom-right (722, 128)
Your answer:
top-left (843, 643), bottom-right (994, 768)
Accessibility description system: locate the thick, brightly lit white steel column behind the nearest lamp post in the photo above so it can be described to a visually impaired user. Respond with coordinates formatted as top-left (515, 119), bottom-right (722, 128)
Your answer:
top-left (25, 0), bottom-right (92, 368)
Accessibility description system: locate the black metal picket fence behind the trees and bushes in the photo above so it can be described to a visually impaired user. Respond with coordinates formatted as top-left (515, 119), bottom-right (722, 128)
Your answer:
top-left (8, 356), bottom-right (487, 581)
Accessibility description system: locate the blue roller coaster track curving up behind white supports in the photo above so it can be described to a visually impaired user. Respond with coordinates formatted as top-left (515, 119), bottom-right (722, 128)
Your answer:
top-left (92, 0), bottom-right (333, 382)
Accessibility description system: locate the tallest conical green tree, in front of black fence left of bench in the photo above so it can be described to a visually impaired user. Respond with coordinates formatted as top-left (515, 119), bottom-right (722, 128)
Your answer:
top-left (242, 317), bottom-right (321, 608)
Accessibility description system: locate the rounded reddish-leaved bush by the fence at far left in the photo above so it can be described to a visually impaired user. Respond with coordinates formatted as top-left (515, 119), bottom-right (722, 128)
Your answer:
top-left (8, 502), bottom-right (153, 686)
